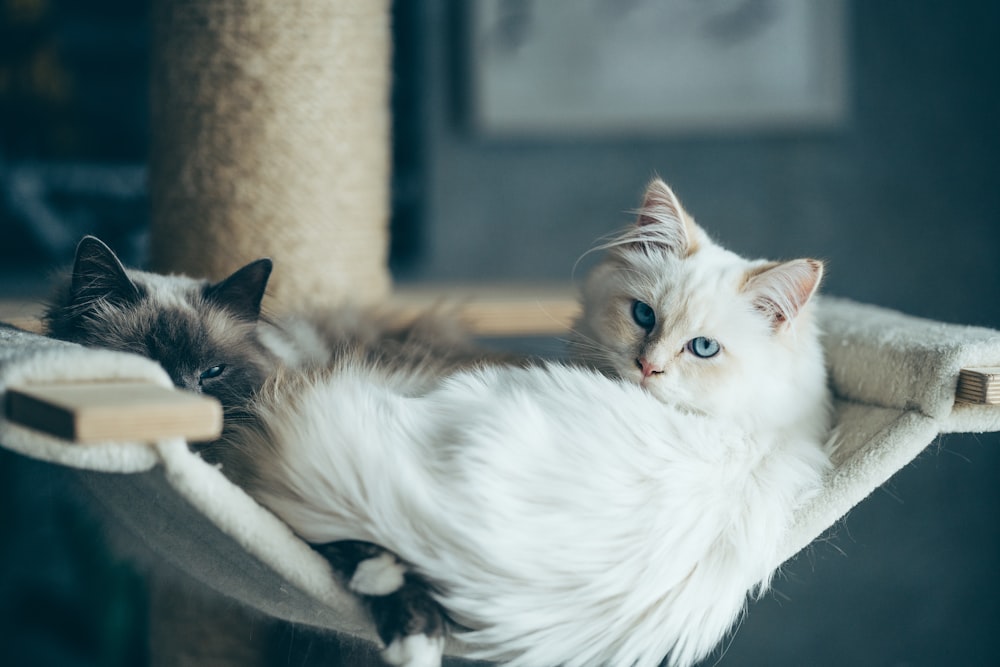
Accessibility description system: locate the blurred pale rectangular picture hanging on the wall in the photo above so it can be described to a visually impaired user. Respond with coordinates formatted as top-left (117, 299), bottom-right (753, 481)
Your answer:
top-left (465, 0), bottom-right (848, 137)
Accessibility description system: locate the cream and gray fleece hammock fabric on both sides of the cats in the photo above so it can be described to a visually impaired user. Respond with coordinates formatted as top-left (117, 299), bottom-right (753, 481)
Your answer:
top-left (0, 298), bottom-right (1000, 656)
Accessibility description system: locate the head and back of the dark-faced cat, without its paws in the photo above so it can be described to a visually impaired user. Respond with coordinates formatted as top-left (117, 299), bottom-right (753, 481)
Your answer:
top-left (43, 236), bottom-right (523, 426)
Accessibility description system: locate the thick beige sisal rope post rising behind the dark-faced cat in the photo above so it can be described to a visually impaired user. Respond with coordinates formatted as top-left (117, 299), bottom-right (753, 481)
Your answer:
top-left (150, 0), bottom-right (391, 310)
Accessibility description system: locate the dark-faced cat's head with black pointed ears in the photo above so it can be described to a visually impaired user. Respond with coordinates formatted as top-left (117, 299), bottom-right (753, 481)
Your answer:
top-left (45, 237), bottom-right (276, 409)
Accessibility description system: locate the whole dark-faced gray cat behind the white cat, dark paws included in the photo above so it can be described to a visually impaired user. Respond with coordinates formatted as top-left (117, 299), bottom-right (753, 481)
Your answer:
top-left (44, 236), bottom-right (498, 663)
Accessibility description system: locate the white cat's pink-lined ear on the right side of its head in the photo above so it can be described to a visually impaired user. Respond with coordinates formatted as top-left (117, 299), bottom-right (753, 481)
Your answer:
top-left (743, 259), bottom-right (823, 330)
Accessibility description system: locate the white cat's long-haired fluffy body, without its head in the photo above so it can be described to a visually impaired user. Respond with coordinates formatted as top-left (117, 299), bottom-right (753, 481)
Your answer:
top-left (256, 367), bottom-right (826, 665)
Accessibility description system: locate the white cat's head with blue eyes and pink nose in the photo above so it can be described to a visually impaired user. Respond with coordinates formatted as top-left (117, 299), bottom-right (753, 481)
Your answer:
top-left (570, 179), bottom-right (830, 448)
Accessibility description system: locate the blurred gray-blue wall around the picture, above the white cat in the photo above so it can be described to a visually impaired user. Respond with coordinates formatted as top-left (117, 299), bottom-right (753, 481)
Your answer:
top-left (401, 0), bottom-right (1000, 326)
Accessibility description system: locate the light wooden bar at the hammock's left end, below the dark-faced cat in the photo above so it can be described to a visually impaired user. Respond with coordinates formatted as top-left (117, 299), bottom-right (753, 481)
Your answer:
top-left (5, 381), bottom-right (222, 443)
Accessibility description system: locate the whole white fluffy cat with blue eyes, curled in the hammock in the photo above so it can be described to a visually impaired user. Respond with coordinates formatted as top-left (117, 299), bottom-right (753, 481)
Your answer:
top-left (224, 180), bottom-right (829, 666)
